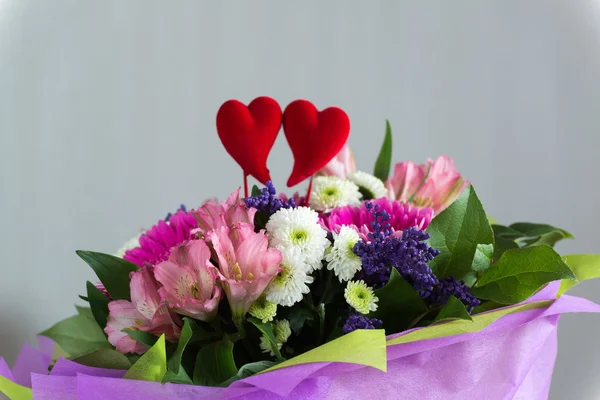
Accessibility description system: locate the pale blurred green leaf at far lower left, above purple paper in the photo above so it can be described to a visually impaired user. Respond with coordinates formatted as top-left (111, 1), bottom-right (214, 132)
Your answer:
top-left (40, 307), bottom-right (112, 357)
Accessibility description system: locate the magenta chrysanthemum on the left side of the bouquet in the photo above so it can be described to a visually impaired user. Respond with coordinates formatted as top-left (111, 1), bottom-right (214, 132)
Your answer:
top-left (123, 210), bottom-right (198, 267)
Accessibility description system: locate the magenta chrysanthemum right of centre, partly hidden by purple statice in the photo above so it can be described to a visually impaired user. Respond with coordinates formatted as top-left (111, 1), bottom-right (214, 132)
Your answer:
top-left (321, 198), bottom-right (433, 240)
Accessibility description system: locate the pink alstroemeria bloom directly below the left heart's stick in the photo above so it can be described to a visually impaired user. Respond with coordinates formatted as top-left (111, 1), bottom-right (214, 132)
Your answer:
top-left (192, 188), bottom-right (256, 235)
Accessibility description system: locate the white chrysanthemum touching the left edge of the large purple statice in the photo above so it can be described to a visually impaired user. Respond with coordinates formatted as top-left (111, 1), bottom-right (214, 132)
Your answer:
top-left (325, 226), bottom-right (362, 282)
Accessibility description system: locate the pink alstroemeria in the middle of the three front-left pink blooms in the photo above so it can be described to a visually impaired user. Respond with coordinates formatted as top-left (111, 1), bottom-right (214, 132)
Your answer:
top-left (154, 240), bottom-right (221, 321)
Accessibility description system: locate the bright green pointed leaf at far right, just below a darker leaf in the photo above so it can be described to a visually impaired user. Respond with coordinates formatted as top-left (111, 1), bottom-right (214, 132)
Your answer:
top-left (471, 245), bottom-right (576, 304)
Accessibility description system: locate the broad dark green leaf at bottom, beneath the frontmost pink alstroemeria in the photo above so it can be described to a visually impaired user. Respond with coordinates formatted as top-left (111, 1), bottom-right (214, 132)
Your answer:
top-left (194, 335), bottom-right (238, 386)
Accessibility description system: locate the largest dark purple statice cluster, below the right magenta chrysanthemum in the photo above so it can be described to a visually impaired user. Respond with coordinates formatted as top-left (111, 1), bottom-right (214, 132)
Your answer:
top-left (353, 203), bottom-right (439, 298)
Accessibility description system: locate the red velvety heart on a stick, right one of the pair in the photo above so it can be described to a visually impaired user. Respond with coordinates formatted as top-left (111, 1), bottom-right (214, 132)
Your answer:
top-left (283, 100), bottom-right (350, 187)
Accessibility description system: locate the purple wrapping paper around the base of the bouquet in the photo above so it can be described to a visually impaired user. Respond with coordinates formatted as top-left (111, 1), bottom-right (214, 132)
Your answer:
top-left (0, 285), bottom-right (600, 400)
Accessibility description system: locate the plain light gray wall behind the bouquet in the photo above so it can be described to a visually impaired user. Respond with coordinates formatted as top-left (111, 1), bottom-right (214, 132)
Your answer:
top-left (0, 0), bottom-right (600, 399)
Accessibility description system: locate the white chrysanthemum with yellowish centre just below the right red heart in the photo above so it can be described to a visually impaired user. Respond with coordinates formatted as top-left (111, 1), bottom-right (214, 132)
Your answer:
top-left (309, 176), bottom-right (361, 212)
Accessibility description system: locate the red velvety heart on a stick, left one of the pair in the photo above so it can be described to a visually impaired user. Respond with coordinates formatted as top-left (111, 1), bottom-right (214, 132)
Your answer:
top-left (217, 96), bottom-right (282, 184)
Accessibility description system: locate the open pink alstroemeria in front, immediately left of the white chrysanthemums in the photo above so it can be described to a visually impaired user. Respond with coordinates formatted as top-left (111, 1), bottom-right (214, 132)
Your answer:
top-left (206, 222), bottom-right (281, 321)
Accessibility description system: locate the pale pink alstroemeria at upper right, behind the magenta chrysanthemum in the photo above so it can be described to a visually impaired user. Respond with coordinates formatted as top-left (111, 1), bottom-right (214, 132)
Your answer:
top-left (386, 156), bottom-right (469, 215)
